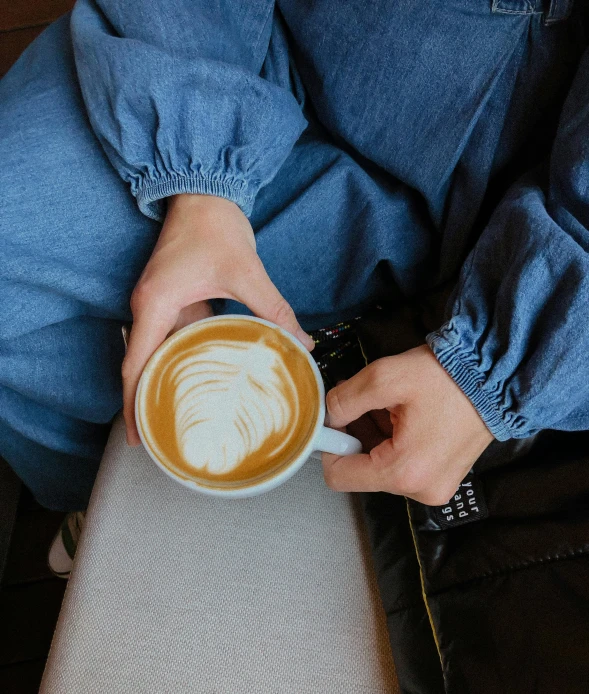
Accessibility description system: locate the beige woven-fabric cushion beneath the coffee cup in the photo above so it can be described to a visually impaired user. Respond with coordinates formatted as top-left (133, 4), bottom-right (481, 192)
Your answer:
top-left (41, 418), bottom-right (398, 694)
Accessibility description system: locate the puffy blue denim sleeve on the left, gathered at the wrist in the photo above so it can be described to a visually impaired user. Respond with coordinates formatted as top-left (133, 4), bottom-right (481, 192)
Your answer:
top-left (71, 0), bottom-right (307, 220)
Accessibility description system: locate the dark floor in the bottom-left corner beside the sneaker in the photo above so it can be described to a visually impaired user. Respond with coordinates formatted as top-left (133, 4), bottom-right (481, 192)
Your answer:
top-left (0, 460), bottom-right (66, 694)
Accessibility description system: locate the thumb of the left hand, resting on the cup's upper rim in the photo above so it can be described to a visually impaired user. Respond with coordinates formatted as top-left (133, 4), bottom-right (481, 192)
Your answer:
top-left (230, 257), bottom-right (315, 351)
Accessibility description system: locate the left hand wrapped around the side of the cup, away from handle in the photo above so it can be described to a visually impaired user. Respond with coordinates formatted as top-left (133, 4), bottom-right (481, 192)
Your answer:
top-left (122, 195), bottom-right (314, 446)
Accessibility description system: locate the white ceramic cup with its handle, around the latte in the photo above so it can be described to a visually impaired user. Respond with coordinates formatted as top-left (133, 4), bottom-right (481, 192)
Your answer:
top-left (135, 315), bottom-right (362, 499)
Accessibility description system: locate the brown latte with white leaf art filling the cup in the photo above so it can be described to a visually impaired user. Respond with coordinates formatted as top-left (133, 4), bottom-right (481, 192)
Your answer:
top-left (137, 317), bottom-right (320, 489)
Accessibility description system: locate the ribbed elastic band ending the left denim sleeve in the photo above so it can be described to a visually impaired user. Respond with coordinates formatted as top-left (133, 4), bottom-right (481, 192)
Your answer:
top-left (136, 175), bottom-right (255, 218)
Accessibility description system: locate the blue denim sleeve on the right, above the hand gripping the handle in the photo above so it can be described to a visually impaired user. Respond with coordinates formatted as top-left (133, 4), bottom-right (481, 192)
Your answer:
top-left (428, 53), bottom-right (589, 441)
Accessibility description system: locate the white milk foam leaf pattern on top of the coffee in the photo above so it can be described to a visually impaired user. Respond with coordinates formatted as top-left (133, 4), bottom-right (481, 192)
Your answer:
top-left (170, 340), bottom-right (299, 475)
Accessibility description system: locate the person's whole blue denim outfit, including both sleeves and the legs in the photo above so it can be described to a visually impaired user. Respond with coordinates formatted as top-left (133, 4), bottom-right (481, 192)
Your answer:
top-left (0, 0), bottom-right (589, 509)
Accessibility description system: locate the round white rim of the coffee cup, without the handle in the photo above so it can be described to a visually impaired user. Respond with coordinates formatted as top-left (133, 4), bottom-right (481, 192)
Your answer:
top-left (134, 313), bottom-right (325, 499)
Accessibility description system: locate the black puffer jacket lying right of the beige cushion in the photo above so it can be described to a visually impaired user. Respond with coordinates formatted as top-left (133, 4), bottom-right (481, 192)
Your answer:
top-left (318, 304), bottom-right (589, 694)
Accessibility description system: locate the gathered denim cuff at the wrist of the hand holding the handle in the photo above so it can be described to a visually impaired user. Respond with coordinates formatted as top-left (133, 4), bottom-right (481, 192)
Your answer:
top-left (426, 332), bottom-right (512, 441)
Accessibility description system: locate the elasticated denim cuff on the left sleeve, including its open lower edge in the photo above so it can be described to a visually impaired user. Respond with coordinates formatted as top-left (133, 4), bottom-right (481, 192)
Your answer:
top-left (139, 176), bottom-right (255, 222)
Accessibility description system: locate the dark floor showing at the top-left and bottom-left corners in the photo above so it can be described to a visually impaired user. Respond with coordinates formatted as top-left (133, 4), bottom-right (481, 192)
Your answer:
top-left (0, 0), bottom-right (73, 694)
